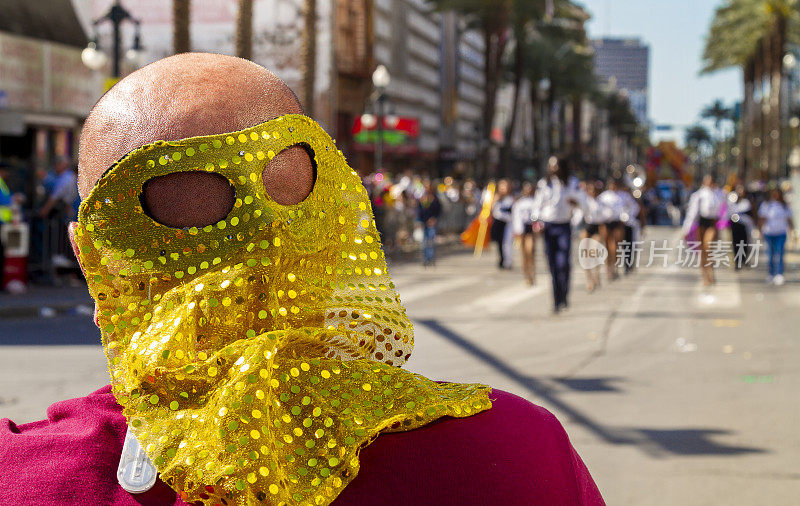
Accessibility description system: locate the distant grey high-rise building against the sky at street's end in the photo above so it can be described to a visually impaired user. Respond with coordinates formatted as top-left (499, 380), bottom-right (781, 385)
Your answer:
top-left (592, 38), bottom-right (650, 125)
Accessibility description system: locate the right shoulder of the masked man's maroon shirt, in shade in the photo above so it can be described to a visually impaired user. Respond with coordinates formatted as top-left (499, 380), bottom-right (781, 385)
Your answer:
top-left (336, 390), bottom-right (603, 505)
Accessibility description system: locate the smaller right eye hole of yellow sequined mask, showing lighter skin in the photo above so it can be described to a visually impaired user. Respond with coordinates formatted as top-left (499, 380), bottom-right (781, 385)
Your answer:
top-left (261, 143), bottom-right (317, 205)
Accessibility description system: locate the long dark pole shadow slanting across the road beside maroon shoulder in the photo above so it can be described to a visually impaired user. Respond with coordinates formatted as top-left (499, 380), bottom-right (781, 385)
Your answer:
top-left (416, 319), bottom-right (767, 456)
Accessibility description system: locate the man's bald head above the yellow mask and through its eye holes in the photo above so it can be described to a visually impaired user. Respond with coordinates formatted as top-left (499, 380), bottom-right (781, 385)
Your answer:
top-left (78, 53), bottom-right (314, 227)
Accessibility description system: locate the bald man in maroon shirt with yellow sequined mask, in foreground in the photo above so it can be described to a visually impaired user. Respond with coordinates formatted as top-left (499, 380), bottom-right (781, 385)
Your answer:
top-left (0, 53), bottom-right (603, 506)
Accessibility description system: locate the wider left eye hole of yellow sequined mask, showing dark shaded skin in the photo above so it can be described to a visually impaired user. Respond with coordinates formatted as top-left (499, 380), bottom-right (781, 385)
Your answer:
top-left (139, 171), bottom-right (236, 228)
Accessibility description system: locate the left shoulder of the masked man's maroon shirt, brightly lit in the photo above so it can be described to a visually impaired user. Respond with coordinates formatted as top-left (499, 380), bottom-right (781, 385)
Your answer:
top-left (0, 387), bottom-right (180, 506)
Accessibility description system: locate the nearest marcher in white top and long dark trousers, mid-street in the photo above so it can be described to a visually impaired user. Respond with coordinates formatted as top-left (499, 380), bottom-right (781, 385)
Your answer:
top-left (533, 156), bottom-right (580, 314)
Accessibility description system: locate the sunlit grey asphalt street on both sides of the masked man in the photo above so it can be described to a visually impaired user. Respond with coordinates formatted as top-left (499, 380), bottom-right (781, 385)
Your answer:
top-left (0, 228), bottom-right (800, 505)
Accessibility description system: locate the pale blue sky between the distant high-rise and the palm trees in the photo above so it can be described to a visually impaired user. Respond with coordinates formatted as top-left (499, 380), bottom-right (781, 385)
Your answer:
top-left (578, 0), bottom-right (742, 141)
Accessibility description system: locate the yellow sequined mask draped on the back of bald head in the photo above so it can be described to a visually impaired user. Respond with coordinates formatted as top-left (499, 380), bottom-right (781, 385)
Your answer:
top-left (76, 115), bottom-right (491, 504)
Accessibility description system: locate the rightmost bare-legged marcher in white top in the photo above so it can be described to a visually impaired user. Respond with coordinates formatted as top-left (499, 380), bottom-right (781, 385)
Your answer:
top-left (683, 174), bottom-right (725, 286)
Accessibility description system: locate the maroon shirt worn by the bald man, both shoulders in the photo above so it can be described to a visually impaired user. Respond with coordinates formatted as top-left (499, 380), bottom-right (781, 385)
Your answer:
top-left (0, 387), bottom-right (604, 506)
